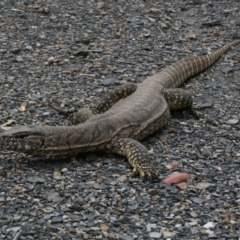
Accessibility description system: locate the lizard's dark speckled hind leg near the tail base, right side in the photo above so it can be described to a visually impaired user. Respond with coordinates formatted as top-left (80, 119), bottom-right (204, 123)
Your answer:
top-left (163, 88), bottom-right (199, 119)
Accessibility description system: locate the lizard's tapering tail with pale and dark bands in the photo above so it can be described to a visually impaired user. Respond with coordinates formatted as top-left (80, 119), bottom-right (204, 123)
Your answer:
top-left (157, 39), bottom-right (240, 88)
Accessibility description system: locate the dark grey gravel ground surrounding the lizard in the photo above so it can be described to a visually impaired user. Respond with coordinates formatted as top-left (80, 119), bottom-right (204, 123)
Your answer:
top-left (0, 0), bottom-right (240, 240)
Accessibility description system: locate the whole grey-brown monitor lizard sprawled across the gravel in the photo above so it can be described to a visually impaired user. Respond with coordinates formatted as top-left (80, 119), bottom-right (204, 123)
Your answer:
top-left (0, 40), bottom-right (240, 178)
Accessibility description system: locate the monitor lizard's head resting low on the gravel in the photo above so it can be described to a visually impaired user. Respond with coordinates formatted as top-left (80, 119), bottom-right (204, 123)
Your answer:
top-left (0, 126), bottom-right (45, 155)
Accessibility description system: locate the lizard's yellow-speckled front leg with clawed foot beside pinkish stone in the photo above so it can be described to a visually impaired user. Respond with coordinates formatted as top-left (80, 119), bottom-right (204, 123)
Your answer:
top-left (110, 138), bottom-right (159, 179)
